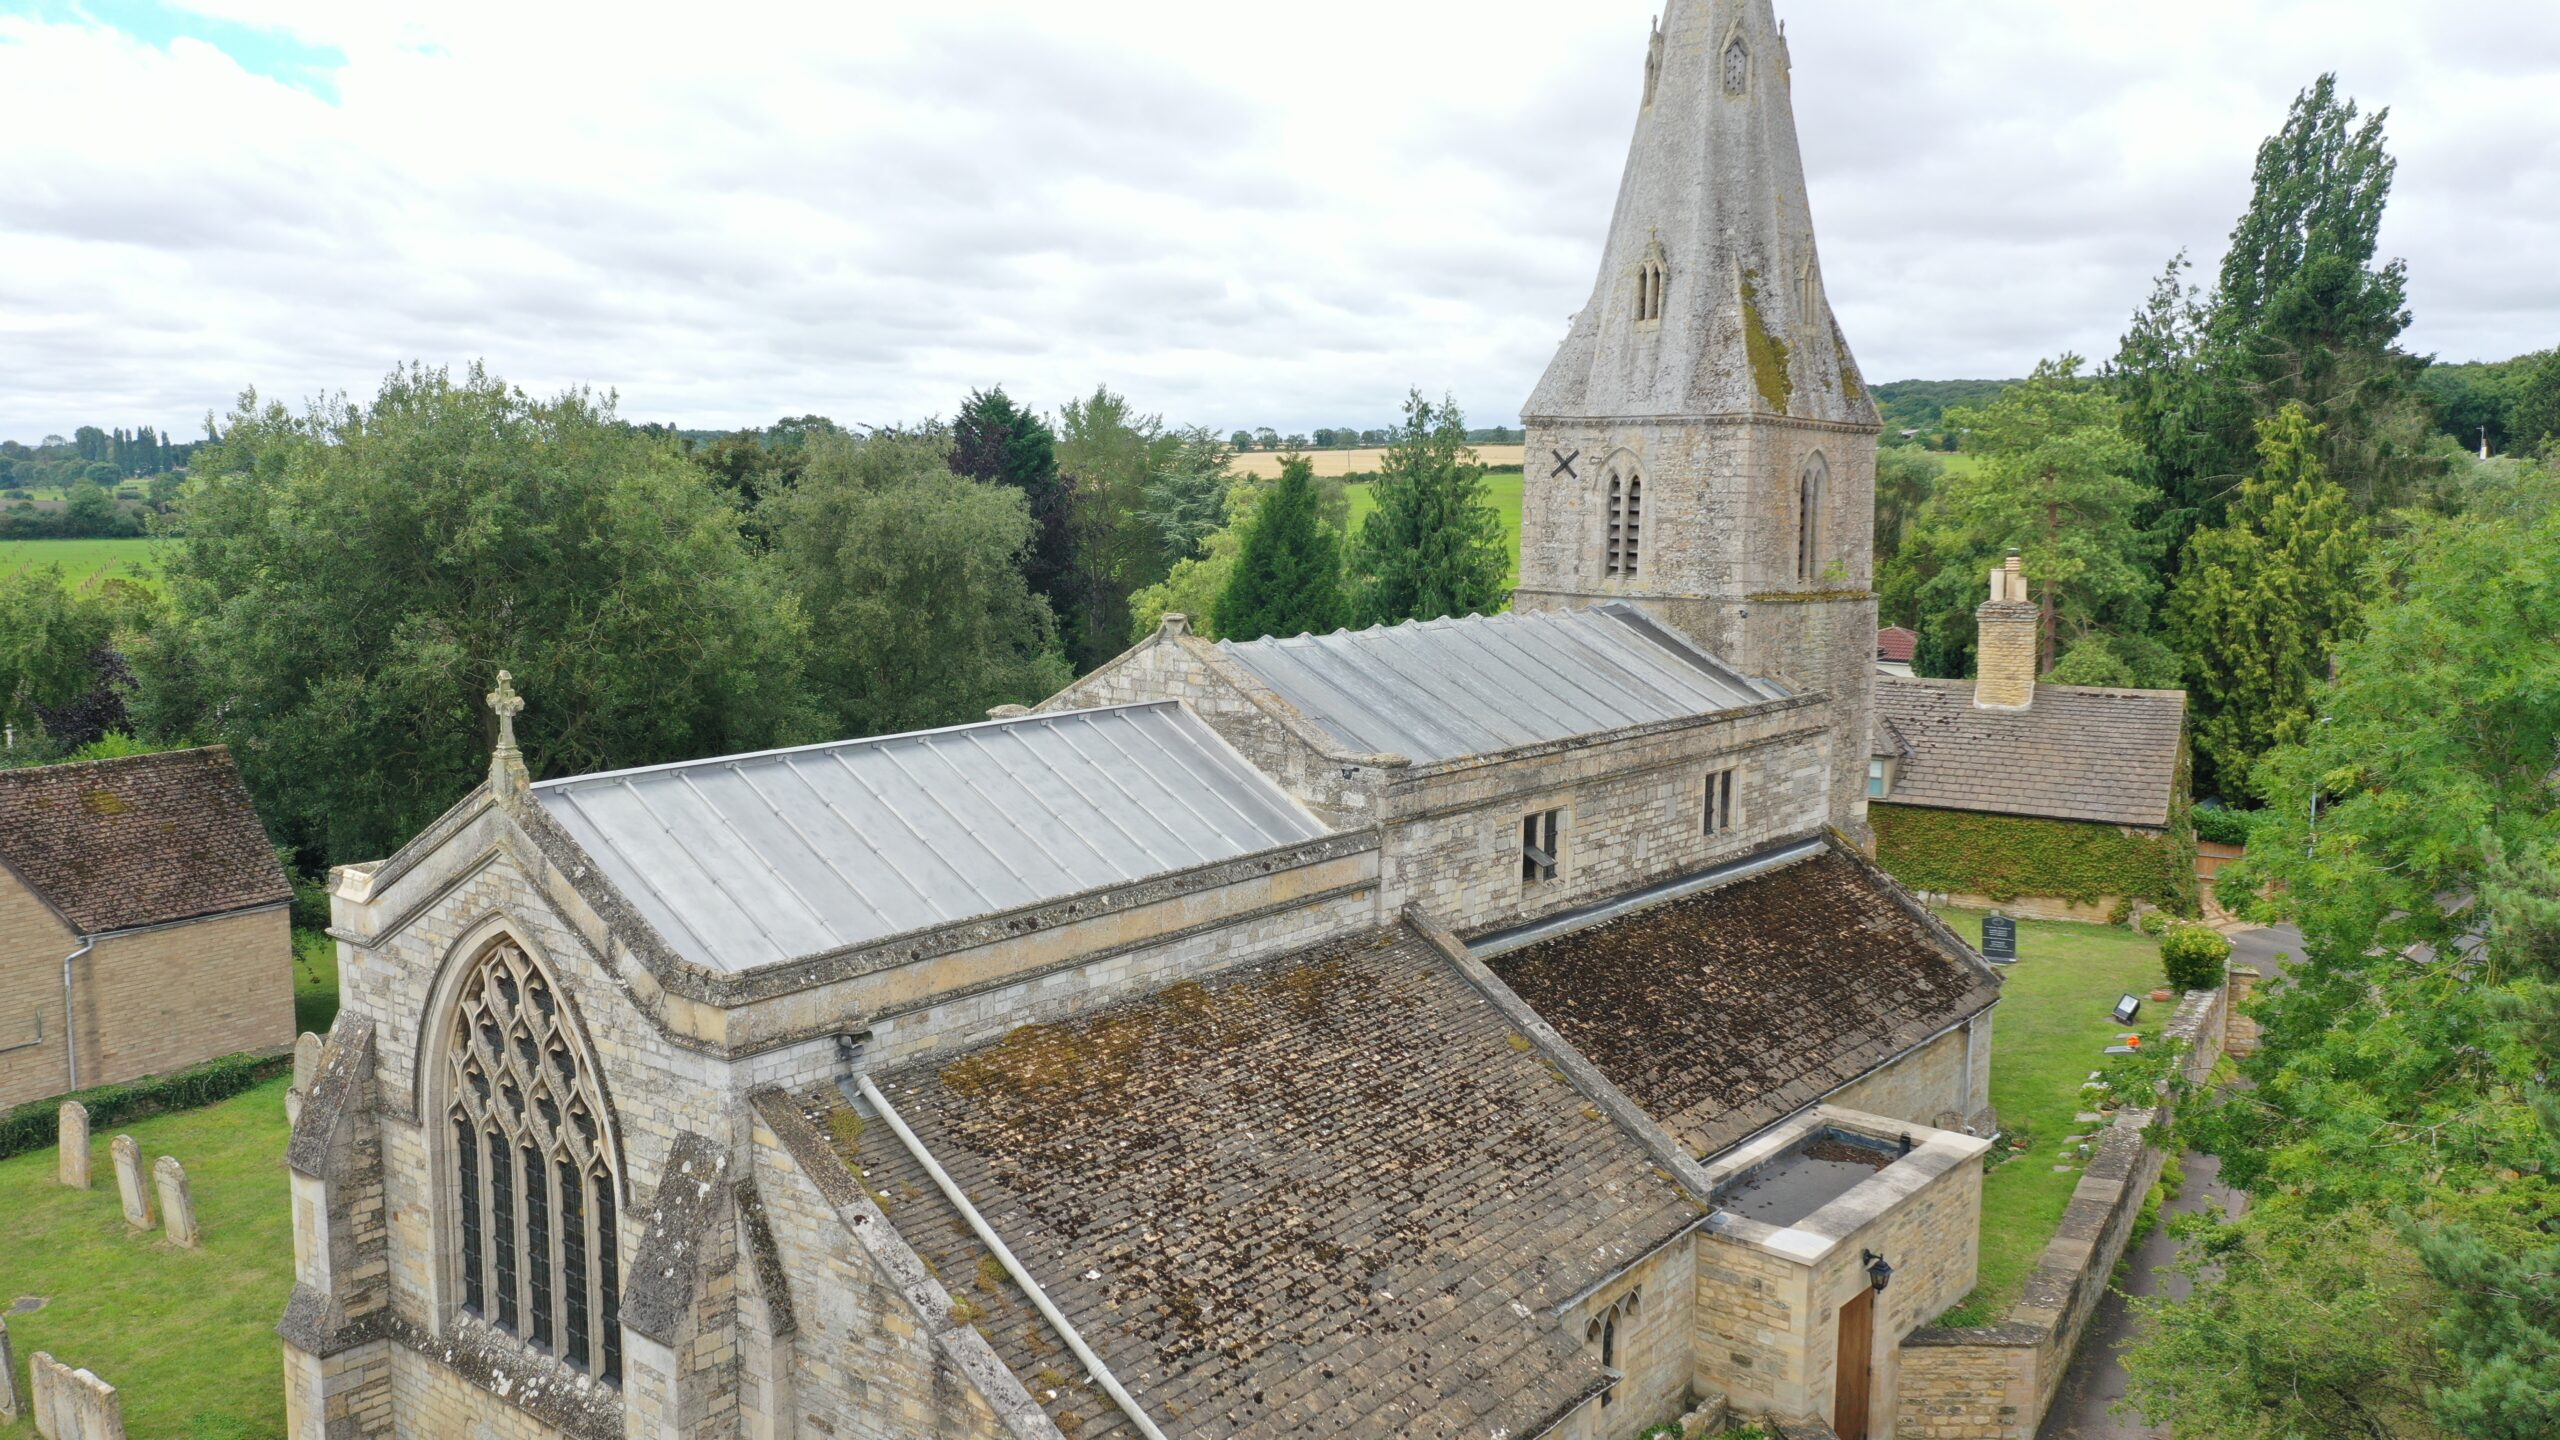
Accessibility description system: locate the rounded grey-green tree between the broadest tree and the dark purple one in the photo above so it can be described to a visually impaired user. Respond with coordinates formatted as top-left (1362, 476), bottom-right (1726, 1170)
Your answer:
top-left (760, 430), bottom-right (1073, 735)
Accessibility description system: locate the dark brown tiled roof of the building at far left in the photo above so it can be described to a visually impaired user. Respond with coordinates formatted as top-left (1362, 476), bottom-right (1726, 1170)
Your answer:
top-left (0, 746), bottom-right (294, 935)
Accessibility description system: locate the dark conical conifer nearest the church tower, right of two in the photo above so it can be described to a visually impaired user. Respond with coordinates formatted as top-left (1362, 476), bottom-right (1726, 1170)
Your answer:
top-left (1352, 389), bottom-right (1510, 625)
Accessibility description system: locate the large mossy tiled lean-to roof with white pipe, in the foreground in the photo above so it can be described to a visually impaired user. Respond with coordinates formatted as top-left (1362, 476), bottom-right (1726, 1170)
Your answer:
top-left (834, 928), bottom-right (1700, 1440)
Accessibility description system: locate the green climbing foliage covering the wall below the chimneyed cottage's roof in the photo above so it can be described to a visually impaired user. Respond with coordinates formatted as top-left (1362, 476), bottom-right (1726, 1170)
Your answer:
top-left (1866, 802), bottom-right (2196, 915)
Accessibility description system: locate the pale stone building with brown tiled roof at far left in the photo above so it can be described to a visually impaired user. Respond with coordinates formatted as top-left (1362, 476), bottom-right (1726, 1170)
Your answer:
top-left (0, 746), bottom-right (294, 1107)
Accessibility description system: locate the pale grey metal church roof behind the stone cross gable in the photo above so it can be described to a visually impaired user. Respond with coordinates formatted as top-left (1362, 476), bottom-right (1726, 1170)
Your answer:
top-left (532, 702), bottom-right (1326, 971)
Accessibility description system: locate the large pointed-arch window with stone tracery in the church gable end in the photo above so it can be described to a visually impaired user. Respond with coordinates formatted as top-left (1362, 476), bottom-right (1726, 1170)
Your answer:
top-left (445, 940), bottom-right (622, 1384)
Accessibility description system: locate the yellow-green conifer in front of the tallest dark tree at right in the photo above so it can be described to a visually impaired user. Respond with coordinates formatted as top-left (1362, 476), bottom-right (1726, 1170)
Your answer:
top-left (2168, 405), bottom-right (2368, 797)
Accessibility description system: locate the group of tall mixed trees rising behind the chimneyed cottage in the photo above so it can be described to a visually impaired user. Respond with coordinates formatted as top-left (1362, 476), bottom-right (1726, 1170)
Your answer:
top-left (1876, 77), bottom-right (2560, 805)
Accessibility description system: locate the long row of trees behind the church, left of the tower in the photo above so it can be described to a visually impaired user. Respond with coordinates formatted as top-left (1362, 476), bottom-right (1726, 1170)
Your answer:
top-left (0, 366), bottom-right (1508, 869)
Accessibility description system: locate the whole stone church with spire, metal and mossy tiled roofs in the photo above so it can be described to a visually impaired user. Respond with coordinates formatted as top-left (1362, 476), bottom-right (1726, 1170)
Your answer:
top-left (279, 0), bottom-right (1999, 1440)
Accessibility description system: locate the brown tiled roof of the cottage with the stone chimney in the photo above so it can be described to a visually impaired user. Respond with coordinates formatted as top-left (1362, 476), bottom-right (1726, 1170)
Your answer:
top-left (1874, 674), bottom-right (2186, 828)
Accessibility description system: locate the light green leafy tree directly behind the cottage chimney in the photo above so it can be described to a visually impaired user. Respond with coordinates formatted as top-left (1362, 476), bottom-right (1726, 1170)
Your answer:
top-left (1910, 356), bottom-right (2156, 674)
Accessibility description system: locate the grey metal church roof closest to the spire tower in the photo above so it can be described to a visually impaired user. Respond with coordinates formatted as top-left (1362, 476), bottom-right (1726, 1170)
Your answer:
top-left (1219, 602), bottom-right (1787, 761)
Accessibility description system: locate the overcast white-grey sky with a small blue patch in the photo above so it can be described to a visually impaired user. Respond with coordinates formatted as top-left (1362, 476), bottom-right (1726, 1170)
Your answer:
top-left (0, 0), bottom-right (2560, 441)
